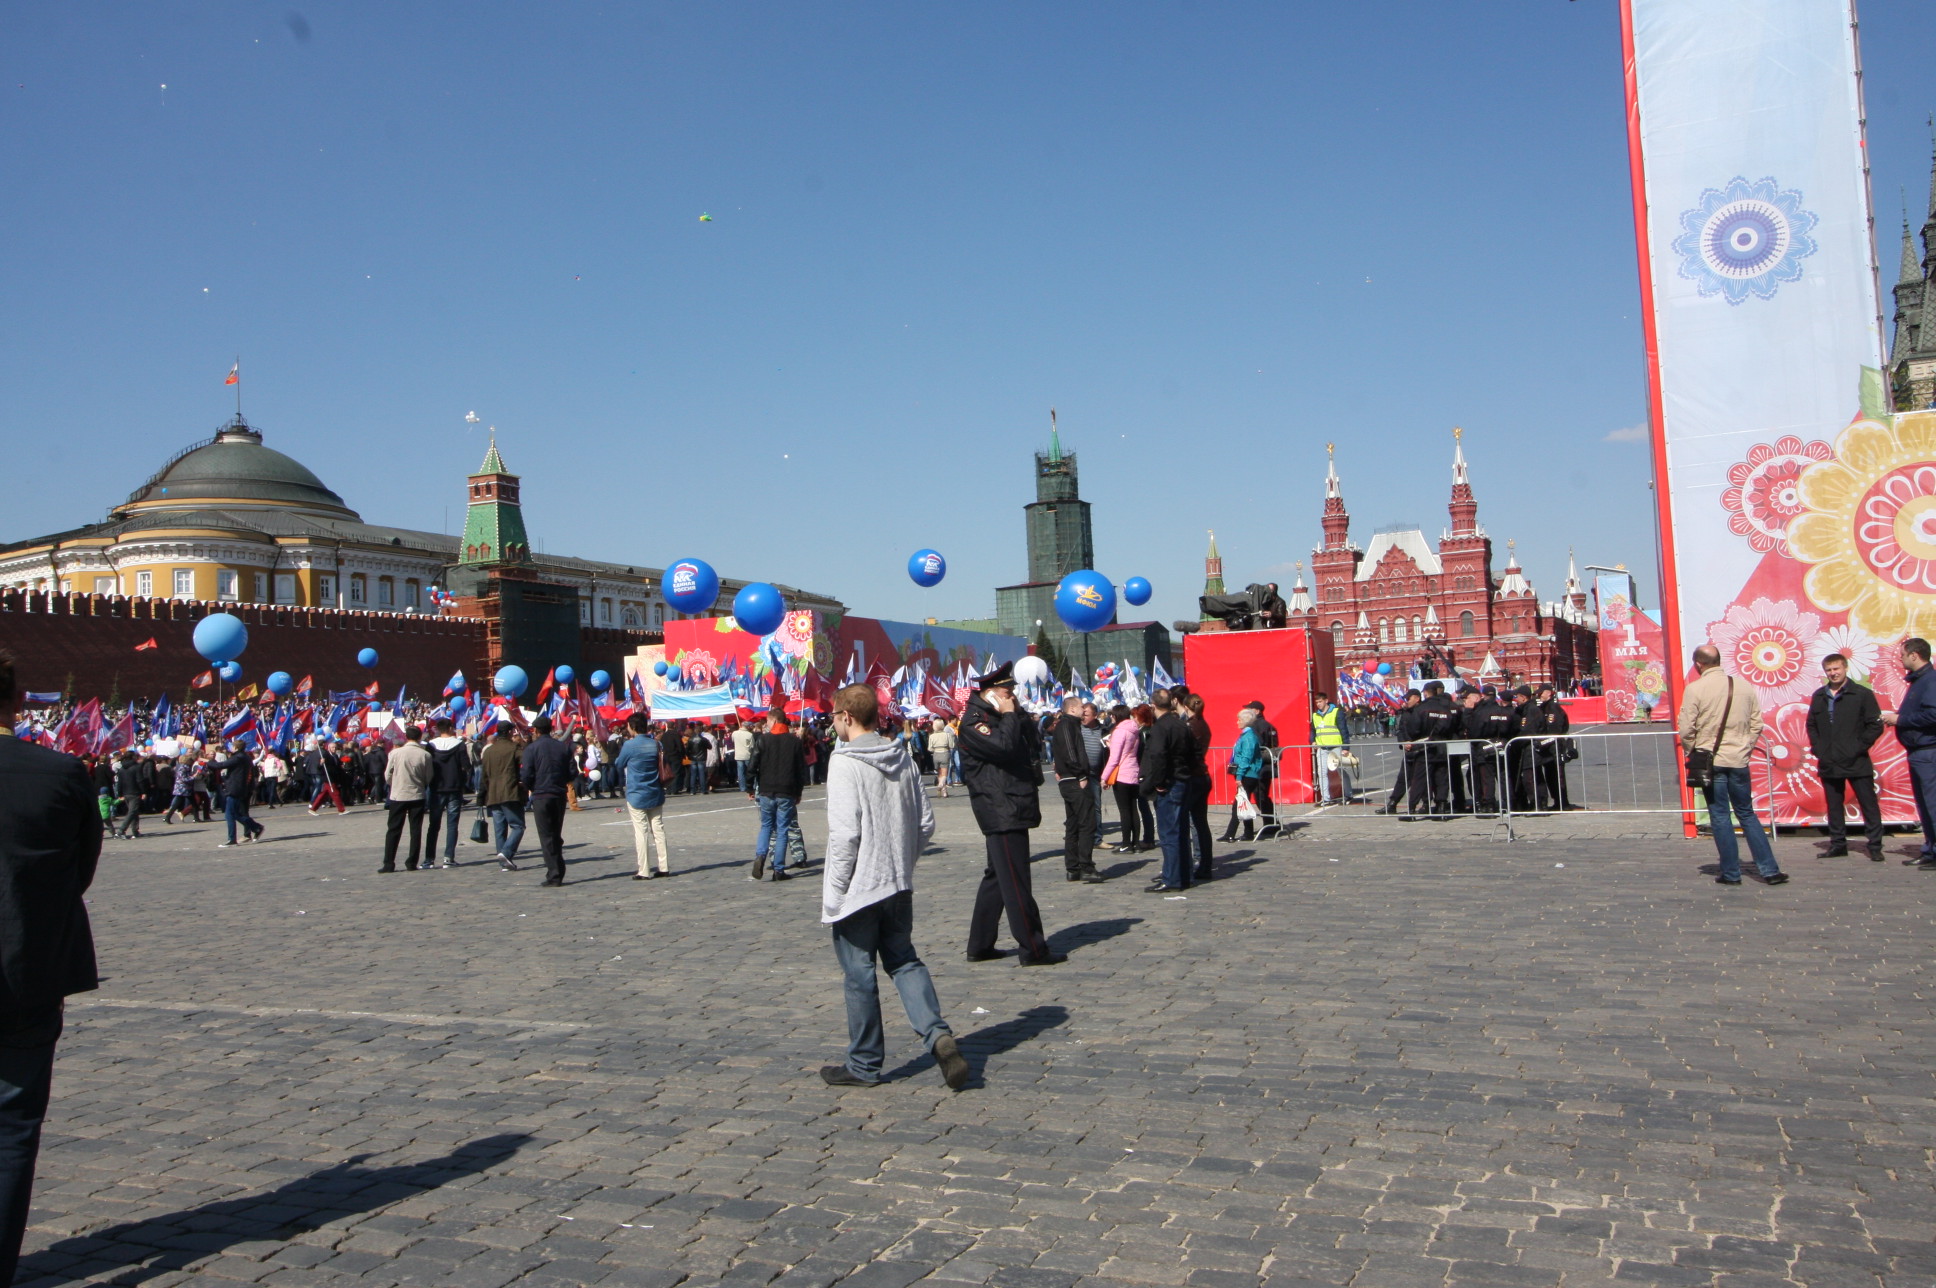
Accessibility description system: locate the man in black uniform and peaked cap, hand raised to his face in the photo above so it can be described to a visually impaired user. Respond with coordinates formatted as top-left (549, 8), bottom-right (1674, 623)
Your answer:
top-left (960, 662), bottom-right (1069, 966)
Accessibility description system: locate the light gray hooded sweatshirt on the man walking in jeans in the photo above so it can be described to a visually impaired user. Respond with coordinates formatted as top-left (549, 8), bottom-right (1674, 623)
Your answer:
top-left (821, 734), bottom-right (935, 926)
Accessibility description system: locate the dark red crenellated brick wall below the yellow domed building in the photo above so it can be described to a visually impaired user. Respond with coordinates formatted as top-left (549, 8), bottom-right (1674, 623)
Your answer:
top-left (0, 591), bottom-right (484, 699)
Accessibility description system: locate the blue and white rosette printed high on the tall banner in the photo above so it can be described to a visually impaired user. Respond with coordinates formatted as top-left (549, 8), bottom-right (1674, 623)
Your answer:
top-left (1675, 174), bottom-right (1816, 304)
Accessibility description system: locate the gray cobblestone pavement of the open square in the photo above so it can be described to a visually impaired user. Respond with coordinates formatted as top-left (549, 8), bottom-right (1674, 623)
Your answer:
top-left (21, 782), bottom-right (1936, 1288)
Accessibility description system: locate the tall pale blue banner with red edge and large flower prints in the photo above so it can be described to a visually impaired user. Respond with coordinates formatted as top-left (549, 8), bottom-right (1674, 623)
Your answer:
top-left (1633, 0), bottom-right (1889, 823)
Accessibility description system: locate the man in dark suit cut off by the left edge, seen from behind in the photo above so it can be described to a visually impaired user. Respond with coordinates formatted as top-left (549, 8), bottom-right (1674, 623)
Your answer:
top-left (0, 651), bottom-right (101, 1284)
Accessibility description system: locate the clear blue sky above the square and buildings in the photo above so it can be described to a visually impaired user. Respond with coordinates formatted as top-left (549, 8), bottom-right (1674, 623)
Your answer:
top-left (0, 0), bottom-right (1936, 620)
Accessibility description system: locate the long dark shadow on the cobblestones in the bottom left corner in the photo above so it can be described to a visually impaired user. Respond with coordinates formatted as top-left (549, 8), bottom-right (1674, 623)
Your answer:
top-left (15, 1131), bottom-right (534, 1284)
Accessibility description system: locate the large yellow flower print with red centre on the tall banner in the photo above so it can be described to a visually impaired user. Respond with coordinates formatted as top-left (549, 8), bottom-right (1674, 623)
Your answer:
top-left (1789, 411), bottom-right (1936, 639)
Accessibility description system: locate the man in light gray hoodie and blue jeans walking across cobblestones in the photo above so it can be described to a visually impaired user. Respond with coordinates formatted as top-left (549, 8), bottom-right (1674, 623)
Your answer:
top-left (821, 684), bottom-right (968, 1090)
